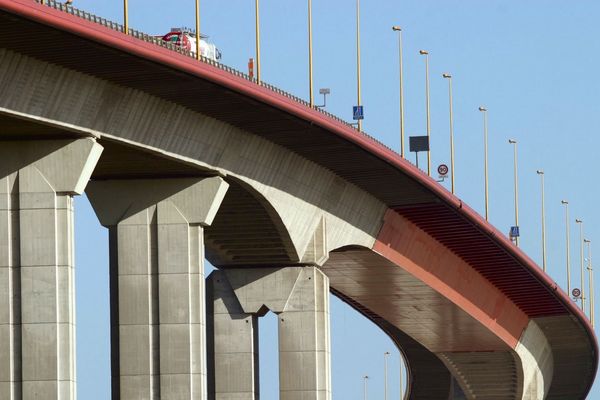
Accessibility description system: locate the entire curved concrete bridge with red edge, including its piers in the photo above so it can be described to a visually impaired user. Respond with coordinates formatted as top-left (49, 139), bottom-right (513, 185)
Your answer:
top-left (0, 0), bottom-right (598, 400)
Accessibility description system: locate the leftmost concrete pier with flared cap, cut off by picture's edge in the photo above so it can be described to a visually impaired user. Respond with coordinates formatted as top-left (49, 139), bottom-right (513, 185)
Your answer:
top-left (0, 139), bottom-right (102, 400)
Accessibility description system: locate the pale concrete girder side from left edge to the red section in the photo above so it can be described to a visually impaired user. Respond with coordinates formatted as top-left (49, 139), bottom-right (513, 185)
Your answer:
top-left (0, 49), bottom-right (386, 265)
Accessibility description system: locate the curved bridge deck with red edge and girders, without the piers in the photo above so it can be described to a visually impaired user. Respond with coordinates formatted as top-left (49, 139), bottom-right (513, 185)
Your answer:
top-left (0, 0), bottom-right (598, 400)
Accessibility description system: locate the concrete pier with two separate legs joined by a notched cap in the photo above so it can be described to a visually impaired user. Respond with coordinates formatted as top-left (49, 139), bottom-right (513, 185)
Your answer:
top-left (207, 267), bottom-right (331, 400)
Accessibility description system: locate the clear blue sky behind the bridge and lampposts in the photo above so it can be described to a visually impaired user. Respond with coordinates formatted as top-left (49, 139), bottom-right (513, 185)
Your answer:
top-left (67, 0), bottom-right (600, 400)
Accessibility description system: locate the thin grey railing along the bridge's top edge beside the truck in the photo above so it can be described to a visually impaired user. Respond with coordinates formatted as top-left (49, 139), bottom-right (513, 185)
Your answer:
top-left (34, 0), bottom-right (397, 154)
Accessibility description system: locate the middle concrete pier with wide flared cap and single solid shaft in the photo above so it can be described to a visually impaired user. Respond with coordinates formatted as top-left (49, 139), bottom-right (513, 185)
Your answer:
top-left (86, 177), bottom-right (228, 400)
